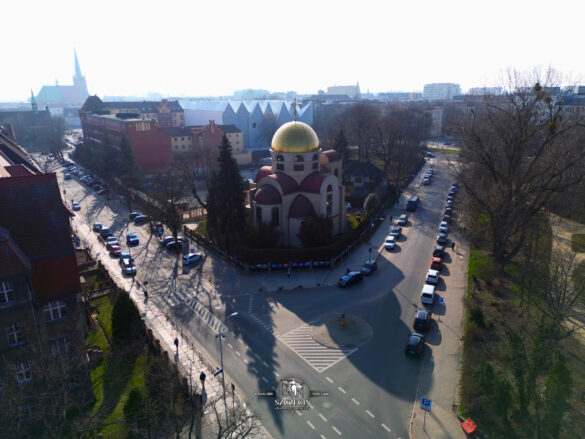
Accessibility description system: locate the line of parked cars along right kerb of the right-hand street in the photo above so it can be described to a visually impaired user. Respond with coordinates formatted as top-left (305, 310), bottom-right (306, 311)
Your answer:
top-left (404, 183), bottom-right (457, 356)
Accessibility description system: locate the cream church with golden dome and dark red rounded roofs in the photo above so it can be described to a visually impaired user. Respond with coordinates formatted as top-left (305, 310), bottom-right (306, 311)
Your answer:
top-left (250, 120), bottom-right (346, 247)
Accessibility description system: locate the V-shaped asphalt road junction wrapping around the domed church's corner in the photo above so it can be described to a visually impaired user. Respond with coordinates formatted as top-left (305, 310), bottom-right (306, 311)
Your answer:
top-left (58, 159), bottom-right (457, 438)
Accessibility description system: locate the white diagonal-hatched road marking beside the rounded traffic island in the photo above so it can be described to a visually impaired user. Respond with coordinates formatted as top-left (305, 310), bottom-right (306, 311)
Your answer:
top-left (279, 324), bottom-right (358, 373)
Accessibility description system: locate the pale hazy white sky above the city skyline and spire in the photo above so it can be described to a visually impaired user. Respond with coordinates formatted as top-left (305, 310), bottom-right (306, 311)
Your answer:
top-left (0, 0), bottom-right (585, 101)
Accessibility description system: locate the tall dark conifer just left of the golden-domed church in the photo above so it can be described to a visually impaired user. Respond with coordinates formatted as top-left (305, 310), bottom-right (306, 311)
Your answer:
top-left (207, 135), bottom-right (246, 251)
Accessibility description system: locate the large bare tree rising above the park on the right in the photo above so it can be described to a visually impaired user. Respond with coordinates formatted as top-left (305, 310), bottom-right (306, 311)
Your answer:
top-left (454, 69), bottom-right (585, 266)
